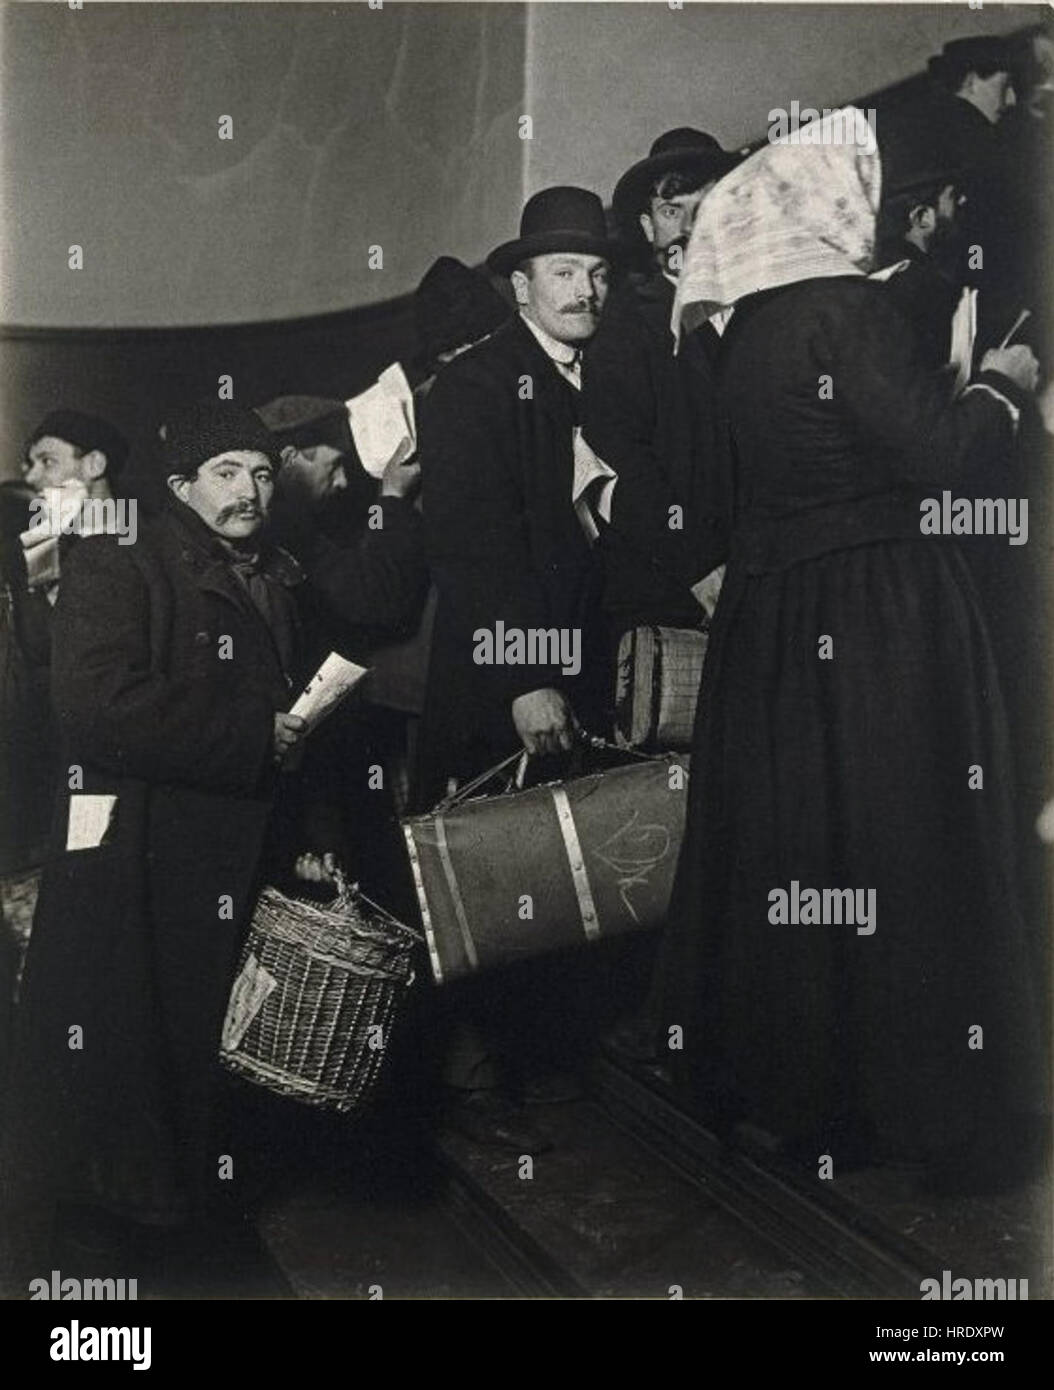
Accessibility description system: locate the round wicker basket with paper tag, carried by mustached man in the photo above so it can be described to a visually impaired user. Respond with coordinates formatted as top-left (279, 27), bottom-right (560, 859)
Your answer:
top-left (220, 876), bottom-right (420, 1113)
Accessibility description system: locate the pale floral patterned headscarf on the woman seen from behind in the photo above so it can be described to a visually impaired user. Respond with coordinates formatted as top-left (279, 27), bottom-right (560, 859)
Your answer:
top-left (672, 106), bottom-right (882, 338)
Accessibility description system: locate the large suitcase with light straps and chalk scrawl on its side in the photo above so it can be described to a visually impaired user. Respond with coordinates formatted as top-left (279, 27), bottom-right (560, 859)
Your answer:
top-left (402, 756), bottom-right (688, 984)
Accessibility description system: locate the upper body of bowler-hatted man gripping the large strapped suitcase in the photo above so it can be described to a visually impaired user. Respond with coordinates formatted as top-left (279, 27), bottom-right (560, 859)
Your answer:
top-left (421, 188), bottom-right (612, 790)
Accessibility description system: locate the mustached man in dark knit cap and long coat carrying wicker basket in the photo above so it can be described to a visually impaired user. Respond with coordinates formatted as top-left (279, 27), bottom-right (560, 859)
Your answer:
top-left (8, 400), bottom-right (425, 1284)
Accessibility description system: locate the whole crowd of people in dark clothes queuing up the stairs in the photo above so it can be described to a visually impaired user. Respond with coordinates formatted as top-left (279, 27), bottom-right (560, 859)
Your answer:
top-left (0, 36), bottom-right (1051, 1289)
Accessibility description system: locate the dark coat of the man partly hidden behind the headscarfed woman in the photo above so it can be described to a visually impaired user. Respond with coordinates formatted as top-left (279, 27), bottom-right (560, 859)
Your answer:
top-left (583, 274), bottom-right (733, 635)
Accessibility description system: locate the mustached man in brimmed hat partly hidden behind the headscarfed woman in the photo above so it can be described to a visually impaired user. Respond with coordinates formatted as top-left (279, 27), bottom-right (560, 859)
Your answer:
top-left (583, 128), bottom-right (737, 648)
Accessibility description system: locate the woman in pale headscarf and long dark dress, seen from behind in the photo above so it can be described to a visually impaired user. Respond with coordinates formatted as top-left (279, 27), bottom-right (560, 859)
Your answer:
top-left (662, 113), bottom-right (1041, 1186)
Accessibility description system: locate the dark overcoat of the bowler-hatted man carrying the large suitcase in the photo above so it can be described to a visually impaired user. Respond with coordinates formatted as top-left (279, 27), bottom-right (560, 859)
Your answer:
top-left (421, 318), bottom-right (606, 790)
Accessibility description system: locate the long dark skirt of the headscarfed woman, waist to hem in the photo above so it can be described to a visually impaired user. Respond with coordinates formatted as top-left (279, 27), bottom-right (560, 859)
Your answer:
top-left (662, 538), bottom-right (1044, 1163)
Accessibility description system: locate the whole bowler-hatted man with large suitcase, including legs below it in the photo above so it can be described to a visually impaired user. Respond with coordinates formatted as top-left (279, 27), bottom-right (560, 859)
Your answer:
top-left (420, 188), bottom-right (612, 1152)
